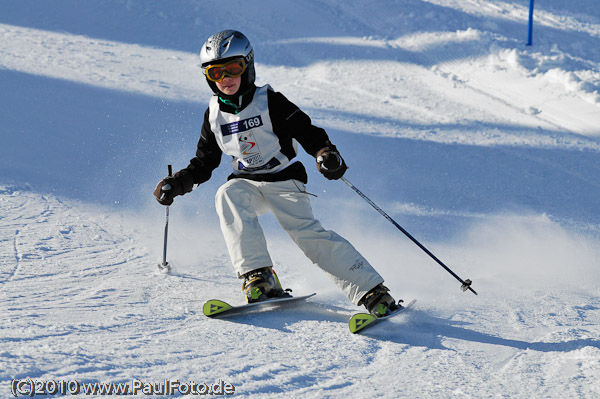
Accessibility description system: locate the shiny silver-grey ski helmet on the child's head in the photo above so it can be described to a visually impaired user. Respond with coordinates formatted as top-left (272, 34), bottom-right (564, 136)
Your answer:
top-left (200, 29), bottom-right (256, 94)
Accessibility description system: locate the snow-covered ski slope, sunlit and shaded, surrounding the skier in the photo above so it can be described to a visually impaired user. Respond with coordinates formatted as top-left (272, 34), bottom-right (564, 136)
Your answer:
top-left (0, 0), bottom-right (600, 398)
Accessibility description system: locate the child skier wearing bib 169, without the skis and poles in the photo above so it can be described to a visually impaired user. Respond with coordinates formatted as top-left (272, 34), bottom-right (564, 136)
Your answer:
top-left (154, 30), bottom-right (398, 316)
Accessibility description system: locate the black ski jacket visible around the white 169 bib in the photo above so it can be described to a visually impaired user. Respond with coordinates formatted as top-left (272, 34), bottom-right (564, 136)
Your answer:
top-left (175, 86), bottom-right (335, 193)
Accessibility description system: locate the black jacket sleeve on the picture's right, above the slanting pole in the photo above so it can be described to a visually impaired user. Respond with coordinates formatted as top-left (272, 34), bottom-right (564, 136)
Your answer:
top-left (268, 91), bottom-right (331, 156)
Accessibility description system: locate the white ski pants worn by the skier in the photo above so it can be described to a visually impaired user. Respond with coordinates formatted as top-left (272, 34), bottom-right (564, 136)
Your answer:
top-left (215, 179), bottom-right (383, 304)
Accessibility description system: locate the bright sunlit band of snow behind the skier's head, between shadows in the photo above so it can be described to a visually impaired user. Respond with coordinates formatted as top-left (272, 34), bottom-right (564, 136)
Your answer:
top-left (0, 2), bottom-right (600, 151)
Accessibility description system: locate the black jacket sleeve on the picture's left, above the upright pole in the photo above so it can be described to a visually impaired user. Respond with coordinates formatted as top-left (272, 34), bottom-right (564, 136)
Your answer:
top-left (175, 109), bottom-right (223, 193)
